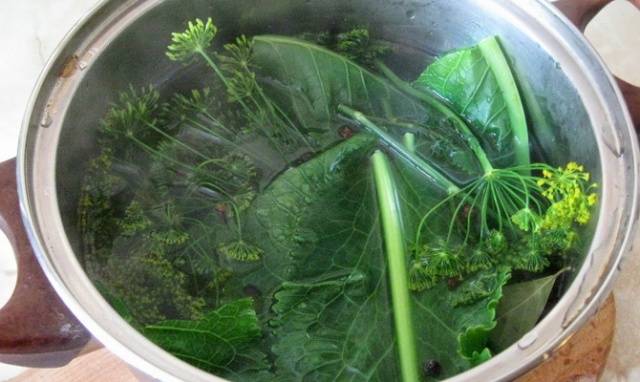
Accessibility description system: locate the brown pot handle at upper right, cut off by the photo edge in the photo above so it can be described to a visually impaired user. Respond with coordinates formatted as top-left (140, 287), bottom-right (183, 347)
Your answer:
top-left (553, 0), bottom-right (640, 127)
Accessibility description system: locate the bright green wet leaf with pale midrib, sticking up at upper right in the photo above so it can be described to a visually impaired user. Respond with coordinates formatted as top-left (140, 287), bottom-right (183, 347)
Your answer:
top-left (414, 37), bottom-right (529, 167)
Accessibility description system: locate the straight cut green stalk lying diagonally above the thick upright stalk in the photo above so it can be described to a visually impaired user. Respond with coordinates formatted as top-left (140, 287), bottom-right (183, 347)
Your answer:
top-left (338, 105), bottom-right (460, 195)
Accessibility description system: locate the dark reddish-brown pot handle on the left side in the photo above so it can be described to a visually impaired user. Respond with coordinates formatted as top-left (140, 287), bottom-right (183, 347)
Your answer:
top-left (0, 159), bottom-right (91, 367)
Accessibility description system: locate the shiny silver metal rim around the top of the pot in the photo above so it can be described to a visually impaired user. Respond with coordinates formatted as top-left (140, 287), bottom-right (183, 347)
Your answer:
top-left (17, 0), bottom-right (640, 382)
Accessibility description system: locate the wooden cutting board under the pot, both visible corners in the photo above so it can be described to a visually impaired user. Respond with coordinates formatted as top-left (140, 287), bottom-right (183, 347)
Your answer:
top-left (11, 296), bottom-right (616, 382)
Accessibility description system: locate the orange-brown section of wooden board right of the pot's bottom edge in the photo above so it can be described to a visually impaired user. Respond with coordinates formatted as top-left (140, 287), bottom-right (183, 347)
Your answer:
top-left (517, 296), bottom-right (616, 382)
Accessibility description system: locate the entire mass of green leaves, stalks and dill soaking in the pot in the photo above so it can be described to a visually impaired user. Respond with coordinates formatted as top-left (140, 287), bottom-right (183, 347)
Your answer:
top-left (79, 19), bottom-right (596, 382)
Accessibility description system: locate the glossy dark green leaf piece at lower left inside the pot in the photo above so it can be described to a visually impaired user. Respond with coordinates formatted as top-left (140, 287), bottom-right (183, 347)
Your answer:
top-left (144, 298), bottom-right (267, 375)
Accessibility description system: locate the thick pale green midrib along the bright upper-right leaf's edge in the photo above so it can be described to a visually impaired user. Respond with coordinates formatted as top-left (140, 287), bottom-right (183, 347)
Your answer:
top-left (478, 37), bottom-right (531, 174)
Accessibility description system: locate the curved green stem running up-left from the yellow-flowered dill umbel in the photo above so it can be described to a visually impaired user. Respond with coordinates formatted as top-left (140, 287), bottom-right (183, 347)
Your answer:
top-left (377, 62), bottom-right (493, 175)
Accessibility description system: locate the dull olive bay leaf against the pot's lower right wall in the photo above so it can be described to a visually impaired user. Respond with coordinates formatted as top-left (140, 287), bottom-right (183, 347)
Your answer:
top-left (490, 273), bottom-right (560, 351)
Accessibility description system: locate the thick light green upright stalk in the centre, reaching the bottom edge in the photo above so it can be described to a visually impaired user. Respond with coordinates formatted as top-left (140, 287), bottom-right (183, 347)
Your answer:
top-left (371, 151), bottom-right (420, 382)
